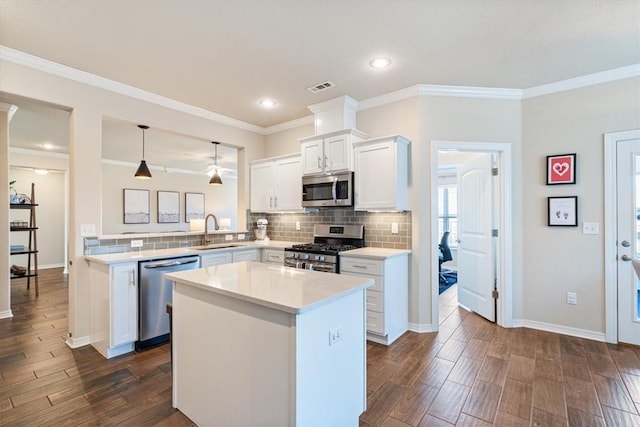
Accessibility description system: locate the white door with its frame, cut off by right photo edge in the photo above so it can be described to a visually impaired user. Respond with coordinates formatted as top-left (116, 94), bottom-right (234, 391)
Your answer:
top-left (605, 130), bottom-right (640, 345)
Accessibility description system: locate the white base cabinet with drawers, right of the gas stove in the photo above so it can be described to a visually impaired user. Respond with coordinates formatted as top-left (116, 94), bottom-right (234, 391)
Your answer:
top-left (340, 253), bottom-right (409, 345)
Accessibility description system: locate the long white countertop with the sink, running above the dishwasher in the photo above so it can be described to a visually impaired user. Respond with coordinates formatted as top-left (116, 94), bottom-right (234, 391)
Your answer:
top-left (84, 240), bottom-right (295, 264)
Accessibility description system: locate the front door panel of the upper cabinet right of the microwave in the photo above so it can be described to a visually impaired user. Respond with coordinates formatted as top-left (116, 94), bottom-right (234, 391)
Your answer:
top-left (354, 142), bottom-right (397, 209)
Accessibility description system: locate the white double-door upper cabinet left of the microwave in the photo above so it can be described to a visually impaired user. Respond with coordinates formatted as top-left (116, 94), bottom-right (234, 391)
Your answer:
top-left (251, 154), bottom-right (302, 212)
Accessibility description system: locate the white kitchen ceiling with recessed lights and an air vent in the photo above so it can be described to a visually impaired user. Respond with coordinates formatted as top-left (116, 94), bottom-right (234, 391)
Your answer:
top-left (0, 0), bottom-right (640, 127)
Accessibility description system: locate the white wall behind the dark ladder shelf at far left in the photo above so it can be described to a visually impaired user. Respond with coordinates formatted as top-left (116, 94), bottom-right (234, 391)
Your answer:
top-left (9, 167), bottom-right (66, 268)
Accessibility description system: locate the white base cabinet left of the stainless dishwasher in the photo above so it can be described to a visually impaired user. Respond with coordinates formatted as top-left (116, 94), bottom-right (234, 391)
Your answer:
top-left (89, 262), bottom-right (138, 358)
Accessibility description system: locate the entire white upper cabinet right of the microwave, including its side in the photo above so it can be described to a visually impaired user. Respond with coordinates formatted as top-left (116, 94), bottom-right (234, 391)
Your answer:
top-left (354, 135), bottom-right (411, 211)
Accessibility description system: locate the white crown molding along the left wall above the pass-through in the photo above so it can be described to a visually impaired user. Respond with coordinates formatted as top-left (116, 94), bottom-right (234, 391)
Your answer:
top-left (0, 45), bottom-right (265, 135)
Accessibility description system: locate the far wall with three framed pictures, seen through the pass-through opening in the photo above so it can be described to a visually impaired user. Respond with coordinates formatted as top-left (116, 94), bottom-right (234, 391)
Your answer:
top-left (102, 163), bottom-right (240, 234)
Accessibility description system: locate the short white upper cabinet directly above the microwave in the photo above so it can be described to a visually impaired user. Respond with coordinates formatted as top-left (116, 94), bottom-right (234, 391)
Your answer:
top-left (299, 129), bottom-right (367, 175)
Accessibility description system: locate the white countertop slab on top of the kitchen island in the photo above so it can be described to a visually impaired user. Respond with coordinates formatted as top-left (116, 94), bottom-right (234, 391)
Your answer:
top-left (166, 262), bottom-right (374, 314)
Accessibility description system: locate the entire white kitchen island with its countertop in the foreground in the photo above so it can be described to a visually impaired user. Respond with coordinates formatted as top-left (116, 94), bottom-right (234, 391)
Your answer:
top-left (167, 262), bottom-right (373, 427)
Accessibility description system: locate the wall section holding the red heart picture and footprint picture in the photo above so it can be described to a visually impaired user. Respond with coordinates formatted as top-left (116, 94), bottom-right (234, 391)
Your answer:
top-left (522, 78), bottom-right (640, 334)
